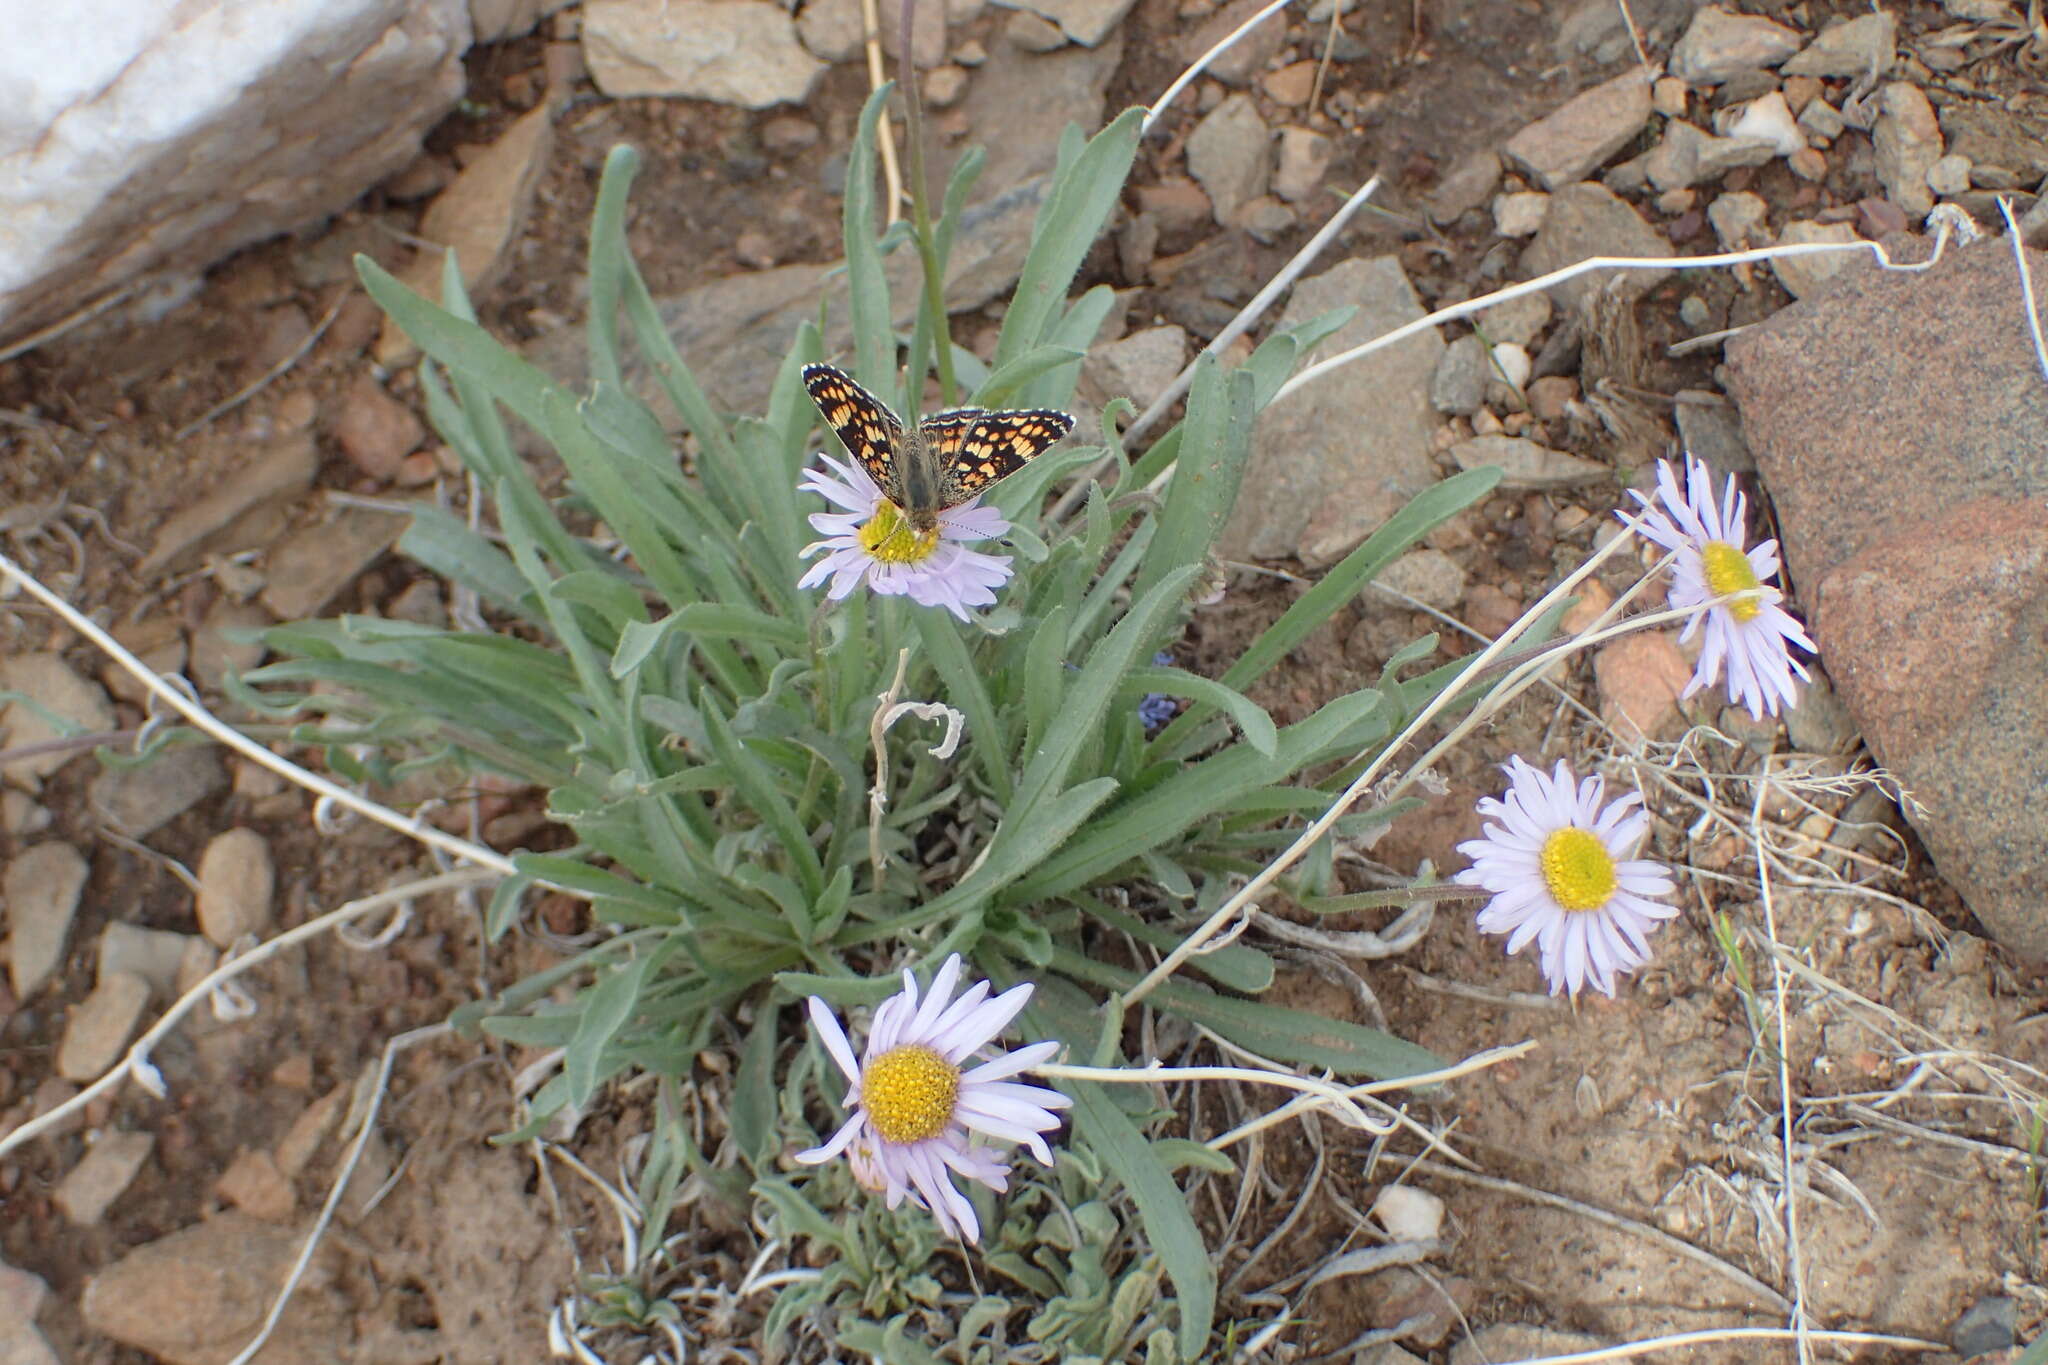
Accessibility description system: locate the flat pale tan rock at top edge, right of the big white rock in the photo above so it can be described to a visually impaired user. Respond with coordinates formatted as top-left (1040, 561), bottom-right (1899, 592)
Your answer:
top-left (584, 0), bottom-right (825, 108)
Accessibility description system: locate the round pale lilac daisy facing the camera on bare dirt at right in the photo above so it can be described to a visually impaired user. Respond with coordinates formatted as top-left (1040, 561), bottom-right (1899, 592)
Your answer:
top-left (1454, 757), bottom-right (1677, 995)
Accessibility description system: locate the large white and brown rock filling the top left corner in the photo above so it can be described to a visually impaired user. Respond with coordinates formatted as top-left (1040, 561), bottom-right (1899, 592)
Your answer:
top-left (0, 0), bottom-right (469, 347)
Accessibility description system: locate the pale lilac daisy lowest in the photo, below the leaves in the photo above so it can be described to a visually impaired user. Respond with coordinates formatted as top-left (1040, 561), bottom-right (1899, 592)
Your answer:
top-left (797, 954), bottom-right (1073, 1242)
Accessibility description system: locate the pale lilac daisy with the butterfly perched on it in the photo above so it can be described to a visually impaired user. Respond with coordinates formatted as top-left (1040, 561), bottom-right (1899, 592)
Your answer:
top-left (797, 454), bottom-right (1012, 620)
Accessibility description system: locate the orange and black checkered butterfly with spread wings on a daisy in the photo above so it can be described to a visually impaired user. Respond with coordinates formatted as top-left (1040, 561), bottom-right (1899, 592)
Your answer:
top-left (803, 364), bottom-right (1073, 534)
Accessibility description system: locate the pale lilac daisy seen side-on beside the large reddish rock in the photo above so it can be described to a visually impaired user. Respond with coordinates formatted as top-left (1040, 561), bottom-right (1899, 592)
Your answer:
top-left (1630, 454), bottom-right (1819, 720)
